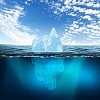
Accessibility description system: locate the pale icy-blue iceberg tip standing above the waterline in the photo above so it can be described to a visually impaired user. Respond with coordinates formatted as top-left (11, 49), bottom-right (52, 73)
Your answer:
top-left (32, 28), bottom-right (63, 52)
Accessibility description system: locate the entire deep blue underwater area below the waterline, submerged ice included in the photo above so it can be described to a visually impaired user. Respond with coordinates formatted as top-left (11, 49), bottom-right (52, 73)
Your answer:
top-left (0, 57), bottom-right (100, 100)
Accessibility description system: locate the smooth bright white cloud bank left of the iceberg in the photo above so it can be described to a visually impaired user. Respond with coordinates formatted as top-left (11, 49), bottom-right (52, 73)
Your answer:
top-left (0, 5), bottom-right (37, 45)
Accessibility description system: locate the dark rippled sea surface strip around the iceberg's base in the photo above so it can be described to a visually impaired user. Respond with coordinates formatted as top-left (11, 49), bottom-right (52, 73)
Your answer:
top-left (0, 45), bottom-right (100, 57)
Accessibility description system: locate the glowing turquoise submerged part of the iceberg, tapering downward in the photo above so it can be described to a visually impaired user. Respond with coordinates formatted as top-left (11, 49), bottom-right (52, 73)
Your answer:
top-left (32, 58), bottom-right (64, 90)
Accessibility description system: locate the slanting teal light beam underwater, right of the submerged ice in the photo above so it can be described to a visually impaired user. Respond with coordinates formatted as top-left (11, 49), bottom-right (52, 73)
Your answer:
top-left (58, 58), bottom-right (85, 95)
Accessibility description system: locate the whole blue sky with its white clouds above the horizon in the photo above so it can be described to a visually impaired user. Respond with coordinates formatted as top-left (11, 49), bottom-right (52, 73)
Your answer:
top-left (0, 0), bottom-right (100, 45)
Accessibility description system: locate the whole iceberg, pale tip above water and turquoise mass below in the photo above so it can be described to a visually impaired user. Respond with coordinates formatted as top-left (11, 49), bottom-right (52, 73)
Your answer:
top-left (32, 28), bottom-right (64, 90)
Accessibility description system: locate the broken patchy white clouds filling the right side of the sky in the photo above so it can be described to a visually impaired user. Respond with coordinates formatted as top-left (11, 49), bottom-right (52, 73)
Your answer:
top-left (40, 0), bottom-right (100, 44)
